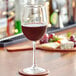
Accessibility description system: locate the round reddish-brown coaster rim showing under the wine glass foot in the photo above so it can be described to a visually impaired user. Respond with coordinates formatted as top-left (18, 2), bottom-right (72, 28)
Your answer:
top-left (19, 69), bottom-right (49, 76)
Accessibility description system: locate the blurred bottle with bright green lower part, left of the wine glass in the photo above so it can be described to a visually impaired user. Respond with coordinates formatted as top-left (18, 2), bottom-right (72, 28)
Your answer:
top-left (15, 0), bottom-right (22, 34)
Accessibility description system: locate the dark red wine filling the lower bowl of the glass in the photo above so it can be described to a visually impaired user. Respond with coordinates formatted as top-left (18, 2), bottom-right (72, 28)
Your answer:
top-left (22, 24), bottom-right (46, 41)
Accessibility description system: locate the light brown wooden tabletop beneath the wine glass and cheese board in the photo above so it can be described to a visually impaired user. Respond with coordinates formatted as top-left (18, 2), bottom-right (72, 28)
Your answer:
top-left (0, 41), bottom-right (76, 76)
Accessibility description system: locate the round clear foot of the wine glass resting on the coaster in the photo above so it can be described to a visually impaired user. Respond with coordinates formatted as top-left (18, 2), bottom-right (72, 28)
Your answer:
top-left (19, 67), bottom-right (48, 76)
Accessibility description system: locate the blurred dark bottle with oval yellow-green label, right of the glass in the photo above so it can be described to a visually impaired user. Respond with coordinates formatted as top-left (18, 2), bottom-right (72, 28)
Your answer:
top-left (49, 0), bottom-right (59, 27)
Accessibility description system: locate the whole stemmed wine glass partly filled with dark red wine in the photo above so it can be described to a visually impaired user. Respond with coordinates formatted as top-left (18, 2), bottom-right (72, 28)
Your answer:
top-left (21, 4), bottom-right (47, 75)
